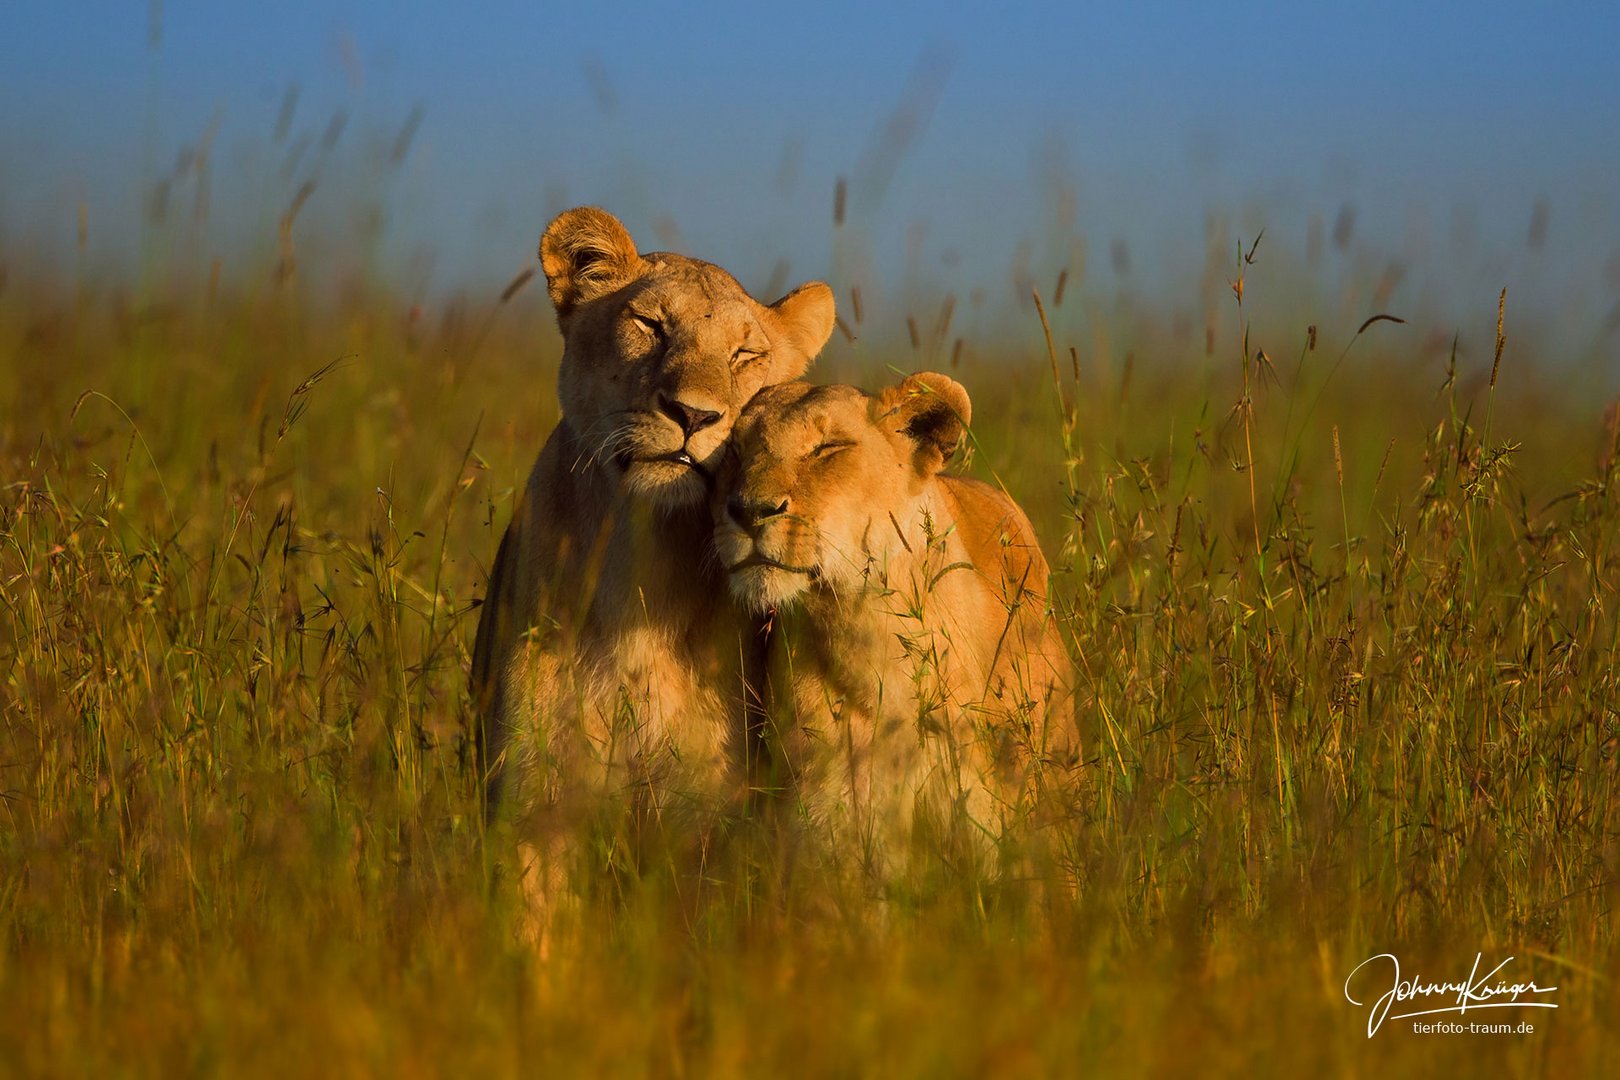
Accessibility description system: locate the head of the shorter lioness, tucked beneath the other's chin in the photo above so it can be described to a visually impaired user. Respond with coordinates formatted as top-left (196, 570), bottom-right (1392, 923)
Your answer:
top-left (711, 371), bottom-right (970, 610)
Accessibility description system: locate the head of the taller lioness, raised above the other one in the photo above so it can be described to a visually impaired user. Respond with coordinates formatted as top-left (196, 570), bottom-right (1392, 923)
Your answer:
top-left (539, 207), bottom-right (833, 508)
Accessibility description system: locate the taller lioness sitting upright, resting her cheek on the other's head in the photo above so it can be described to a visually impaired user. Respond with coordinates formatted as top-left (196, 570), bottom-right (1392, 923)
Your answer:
top-left (471, 207), bottom-right (833, 854)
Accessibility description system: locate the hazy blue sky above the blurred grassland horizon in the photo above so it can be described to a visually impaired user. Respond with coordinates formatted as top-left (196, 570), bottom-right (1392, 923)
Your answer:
top-left (0, 0), bottom-right (1620, 351)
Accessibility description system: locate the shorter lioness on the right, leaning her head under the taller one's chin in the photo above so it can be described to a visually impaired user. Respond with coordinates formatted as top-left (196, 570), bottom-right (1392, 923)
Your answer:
top-left (711, 372), bottom-right (1072, 873)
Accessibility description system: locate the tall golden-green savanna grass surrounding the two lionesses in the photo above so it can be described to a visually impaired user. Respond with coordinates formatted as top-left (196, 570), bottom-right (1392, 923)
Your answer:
top-left (0, 187), bottom-right (1620, 1077)
